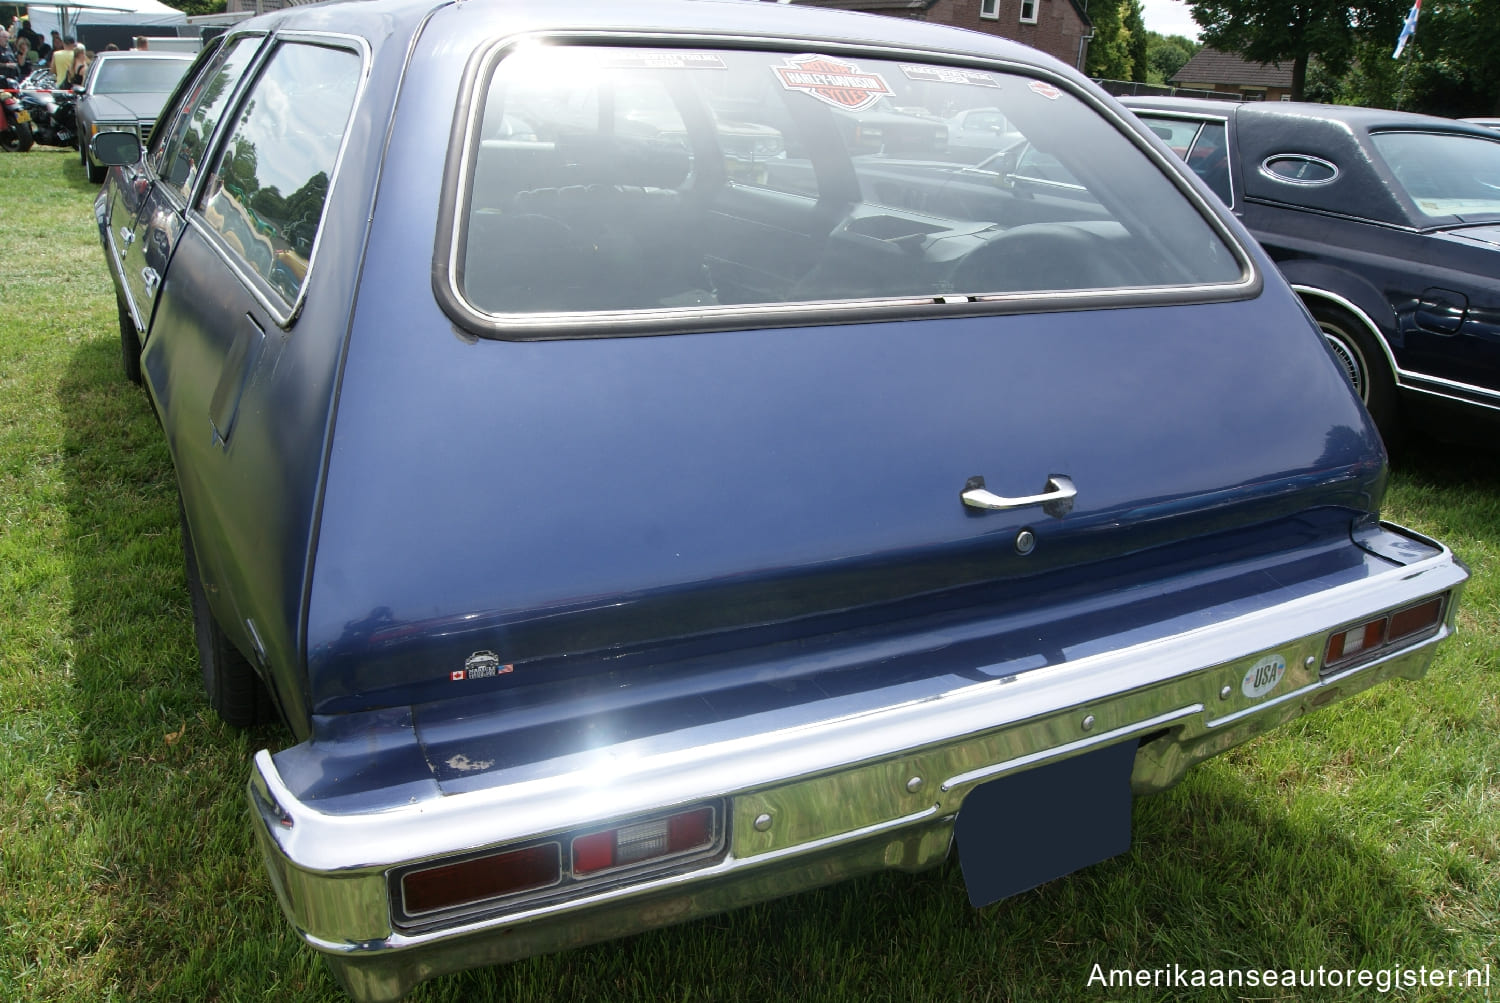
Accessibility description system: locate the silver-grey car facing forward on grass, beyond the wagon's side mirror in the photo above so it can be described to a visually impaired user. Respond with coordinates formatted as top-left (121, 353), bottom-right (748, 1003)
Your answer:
top-left (77, 49), bottom-right (194, 184)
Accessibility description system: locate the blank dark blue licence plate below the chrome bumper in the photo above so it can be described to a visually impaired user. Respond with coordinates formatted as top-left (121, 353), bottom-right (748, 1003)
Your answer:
top-left (954, 742), bottom-right (1136, 906)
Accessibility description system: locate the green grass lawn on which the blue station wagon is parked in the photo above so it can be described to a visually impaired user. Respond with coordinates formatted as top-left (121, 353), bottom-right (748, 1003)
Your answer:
top-left (0, 147), bottom-right (1500, 1003)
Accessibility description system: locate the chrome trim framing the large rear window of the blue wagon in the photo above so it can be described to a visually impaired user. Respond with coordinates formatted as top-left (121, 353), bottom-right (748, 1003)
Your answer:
top-left (432, 30), bottom-right (1263, 340)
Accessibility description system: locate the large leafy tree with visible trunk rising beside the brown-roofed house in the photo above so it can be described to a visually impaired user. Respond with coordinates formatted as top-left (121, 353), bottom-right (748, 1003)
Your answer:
top-left (1187, 0), bottom-right (1409, 100)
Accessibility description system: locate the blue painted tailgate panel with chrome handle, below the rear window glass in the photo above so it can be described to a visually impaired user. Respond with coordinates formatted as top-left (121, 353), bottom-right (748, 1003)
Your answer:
top-left (308, 288), bottom-right (1385, 712)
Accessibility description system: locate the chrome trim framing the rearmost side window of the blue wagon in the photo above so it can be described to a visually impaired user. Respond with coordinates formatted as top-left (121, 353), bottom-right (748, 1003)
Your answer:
top-left (188, 31), bottom-right (371, 331)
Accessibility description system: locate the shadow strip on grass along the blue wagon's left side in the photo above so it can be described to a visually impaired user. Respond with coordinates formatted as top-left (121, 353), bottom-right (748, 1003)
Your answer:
top-left (59, 334), bottom-right (322, 1000)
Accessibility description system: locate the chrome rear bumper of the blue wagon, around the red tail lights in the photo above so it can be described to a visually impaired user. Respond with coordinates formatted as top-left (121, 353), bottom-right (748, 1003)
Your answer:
top-left (249, 527), bottom-right (1469, 1003)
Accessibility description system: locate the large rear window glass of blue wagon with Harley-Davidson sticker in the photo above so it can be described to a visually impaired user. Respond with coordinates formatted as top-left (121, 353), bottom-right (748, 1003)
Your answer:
top-left (453, 46), bottom-right (1244, 315)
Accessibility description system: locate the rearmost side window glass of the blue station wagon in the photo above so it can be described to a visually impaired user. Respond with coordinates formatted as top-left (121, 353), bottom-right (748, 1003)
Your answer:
top-left (201, 42), bottom-right (360, 303)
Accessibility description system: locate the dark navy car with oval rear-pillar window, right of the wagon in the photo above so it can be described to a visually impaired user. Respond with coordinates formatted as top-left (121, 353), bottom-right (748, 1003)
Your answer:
top-left (1124, 97), bottom-right (1500, 436)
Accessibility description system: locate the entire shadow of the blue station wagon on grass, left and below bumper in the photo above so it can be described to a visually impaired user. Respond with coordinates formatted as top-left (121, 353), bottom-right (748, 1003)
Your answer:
top-left (60, 337), bottom-right (1460, 1003)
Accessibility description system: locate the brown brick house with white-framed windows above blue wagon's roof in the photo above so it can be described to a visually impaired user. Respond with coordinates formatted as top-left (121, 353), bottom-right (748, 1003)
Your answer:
top-left (791, 0), bottom-right (1094, 69)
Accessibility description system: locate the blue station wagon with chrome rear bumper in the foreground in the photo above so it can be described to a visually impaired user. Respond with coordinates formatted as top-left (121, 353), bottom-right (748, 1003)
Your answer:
top-left (93, 0), bottom-right (1467, 1000)
